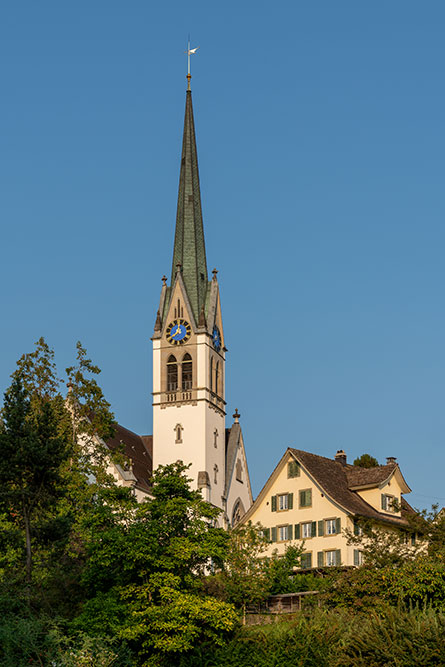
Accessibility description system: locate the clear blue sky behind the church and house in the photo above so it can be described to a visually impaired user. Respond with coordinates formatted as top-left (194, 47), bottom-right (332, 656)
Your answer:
top-left (0, 0), bottom-right (445, 507)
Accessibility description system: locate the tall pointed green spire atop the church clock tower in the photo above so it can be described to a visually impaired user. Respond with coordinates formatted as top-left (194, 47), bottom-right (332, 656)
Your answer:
top-left (171, 82), bottom-right (207, 321)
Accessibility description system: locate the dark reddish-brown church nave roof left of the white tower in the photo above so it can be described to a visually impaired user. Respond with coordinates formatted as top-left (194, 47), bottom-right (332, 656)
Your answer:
top-left (107, 424), bottom-right (153, 492)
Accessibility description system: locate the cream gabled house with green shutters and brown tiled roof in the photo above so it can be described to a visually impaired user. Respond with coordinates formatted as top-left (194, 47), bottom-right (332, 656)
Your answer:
top-left (242, 448), bottom-right (413, 568)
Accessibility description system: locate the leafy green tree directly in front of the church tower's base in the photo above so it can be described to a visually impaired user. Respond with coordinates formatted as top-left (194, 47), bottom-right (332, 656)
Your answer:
top-left (75, 463), bottom-right (237, 665)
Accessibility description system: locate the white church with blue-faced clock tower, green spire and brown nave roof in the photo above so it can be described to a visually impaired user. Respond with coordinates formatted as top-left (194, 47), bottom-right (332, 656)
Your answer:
top-left (102, 73), bottom-right (252, 527)
